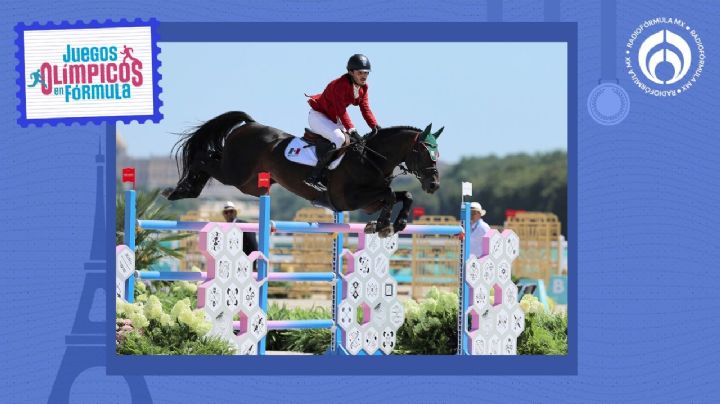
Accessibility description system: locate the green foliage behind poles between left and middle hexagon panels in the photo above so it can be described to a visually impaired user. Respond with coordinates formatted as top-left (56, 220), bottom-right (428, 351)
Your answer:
top-left (266, 303), bottom-right (332, 355)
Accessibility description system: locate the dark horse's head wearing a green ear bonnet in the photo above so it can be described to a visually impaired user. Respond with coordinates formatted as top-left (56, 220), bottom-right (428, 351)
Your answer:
top-left (405, 124), bottom-right (445, 194)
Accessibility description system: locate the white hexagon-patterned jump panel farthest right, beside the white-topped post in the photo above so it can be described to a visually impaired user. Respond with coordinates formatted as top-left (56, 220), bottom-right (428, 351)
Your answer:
top-left (464, 229), bottom-right (525, 355)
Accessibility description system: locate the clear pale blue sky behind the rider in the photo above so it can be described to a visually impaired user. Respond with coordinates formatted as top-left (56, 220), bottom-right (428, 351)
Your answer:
top-left (118, 42), bottom-right (567, 163)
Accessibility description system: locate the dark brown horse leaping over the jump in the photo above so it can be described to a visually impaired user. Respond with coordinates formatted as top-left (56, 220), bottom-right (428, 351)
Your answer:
top-left (163, 111), bottom-right (444, 238)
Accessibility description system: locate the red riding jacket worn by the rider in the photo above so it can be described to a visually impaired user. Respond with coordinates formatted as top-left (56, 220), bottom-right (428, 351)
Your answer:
top-left (308, 74), bottom-right (377, 129)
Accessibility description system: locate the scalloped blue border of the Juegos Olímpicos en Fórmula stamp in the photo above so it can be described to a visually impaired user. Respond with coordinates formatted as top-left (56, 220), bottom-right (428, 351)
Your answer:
top-left (15, 18), bottom-right (163, 128)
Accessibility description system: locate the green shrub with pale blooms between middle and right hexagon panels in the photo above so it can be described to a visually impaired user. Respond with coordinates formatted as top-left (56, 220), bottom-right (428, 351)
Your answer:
top-left (396, 287), bottom-right (458, 355)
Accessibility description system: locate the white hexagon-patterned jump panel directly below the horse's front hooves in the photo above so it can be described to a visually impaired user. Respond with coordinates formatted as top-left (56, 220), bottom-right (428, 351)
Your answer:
top-left (338, 234), bottom-right (405, 355)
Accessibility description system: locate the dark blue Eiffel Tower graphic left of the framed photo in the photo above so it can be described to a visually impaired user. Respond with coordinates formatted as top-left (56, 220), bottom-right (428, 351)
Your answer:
top-left (48, 136), bottom-right (152, 404)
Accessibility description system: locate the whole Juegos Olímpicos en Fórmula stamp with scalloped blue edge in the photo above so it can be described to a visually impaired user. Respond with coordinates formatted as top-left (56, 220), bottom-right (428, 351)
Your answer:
top-left (15, 20), bottom-right (162, 126)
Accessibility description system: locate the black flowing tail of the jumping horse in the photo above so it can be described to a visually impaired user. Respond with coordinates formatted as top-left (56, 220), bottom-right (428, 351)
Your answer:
top-left (171, 111), bottom-right (255, 180)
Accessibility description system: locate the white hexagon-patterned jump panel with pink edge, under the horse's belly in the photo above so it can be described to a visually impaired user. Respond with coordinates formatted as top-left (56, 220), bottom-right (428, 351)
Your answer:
top-left (198, 223), bottom-right (267, 355)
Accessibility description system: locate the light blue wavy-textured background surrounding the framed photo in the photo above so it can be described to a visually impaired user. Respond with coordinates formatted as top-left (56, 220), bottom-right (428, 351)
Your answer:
top-left (0, 0), bottom-right (720, 403)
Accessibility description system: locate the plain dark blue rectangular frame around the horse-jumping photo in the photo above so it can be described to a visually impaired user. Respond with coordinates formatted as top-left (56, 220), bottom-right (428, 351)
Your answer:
top-left (106, 22), bottom-right (578, 375)
